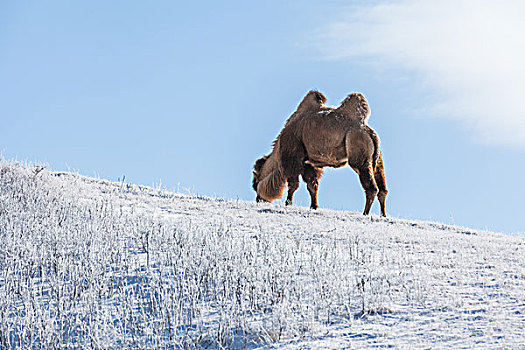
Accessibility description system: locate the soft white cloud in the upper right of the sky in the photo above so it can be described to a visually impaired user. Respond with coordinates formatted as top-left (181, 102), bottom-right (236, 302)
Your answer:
top-left (318, 0), bottom-right (525, 149)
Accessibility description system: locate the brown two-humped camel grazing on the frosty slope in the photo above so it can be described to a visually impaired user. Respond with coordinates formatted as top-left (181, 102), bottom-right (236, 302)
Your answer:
top-left (253, 91), bottom-right (388, 216)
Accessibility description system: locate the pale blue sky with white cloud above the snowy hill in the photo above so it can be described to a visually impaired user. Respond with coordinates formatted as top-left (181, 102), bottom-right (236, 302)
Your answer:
top-left (0, 0), bottom-right (525, 233)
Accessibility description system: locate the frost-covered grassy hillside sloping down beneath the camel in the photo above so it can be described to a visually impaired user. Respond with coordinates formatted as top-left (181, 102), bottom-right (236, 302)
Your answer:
top-left (0, 162), bottom-right (525, 349)
